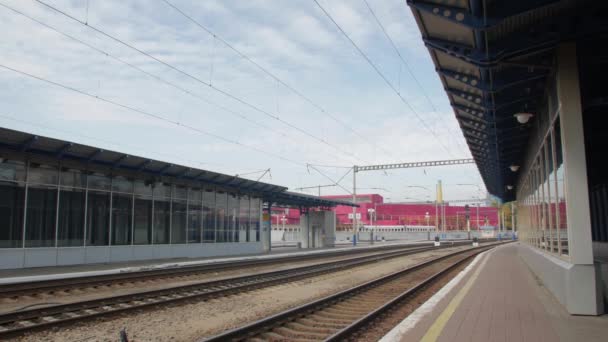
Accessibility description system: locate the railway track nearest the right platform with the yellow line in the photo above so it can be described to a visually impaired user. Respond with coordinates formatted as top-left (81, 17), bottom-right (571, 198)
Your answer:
top-left (204, 246), bottom-right (492, 342)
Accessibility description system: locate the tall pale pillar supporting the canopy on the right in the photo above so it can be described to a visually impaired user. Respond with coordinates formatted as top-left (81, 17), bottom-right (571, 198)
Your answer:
top-left (557, 43), bottom-right (593, 265)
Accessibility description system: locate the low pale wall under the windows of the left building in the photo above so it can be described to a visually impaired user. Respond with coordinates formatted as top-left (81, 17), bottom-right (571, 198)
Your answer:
top-left (0, 242), bottom-right (263, 269)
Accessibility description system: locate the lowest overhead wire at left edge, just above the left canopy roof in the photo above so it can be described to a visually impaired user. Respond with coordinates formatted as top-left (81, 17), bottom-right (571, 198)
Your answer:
top-left (0, 64), bottom-right (307, 166)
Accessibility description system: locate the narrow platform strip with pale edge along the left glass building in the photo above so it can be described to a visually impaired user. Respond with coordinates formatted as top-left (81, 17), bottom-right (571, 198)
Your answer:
top-left (0, 241), bottom-right (433, 284)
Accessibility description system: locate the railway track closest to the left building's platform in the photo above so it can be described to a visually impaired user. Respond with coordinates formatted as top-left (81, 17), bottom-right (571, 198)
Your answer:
top-left (0, 241), bottom-right (470, 299)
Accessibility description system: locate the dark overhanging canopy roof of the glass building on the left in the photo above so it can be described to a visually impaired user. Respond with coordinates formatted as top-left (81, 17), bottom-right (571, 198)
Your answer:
top-left (0, 127), bottom-right (351, 207)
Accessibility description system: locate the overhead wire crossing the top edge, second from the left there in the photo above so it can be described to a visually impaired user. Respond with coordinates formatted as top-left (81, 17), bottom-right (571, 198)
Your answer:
top-left (163, 0), bottom-right (393, 161)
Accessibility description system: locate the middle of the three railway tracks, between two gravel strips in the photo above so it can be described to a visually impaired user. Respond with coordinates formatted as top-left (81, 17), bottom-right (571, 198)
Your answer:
top-left (0, 242), bottom-right (478, 339)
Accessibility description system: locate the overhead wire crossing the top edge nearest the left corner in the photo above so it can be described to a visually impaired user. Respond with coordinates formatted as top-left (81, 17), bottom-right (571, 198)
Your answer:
top-left (34, 0), bottom-right (368, 166)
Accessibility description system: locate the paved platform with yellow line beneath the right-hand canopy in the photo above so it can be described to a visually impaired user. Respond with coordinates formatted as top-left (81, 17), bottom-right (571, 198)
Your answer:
top-left (381, 243), bottom-right (608, 342)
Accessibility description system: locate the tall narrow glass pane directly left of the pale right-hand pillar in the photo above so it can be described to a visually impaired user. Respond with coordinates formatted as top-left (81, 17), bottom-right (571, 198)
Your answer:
top-left (555, 119), bottom-right (568, 255)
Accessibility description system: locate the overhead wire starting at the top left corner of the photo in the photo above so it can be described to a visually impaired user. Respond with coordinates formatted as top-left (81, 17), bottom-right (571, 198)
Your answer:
top-left (0, 3), bottom-right (356, 167)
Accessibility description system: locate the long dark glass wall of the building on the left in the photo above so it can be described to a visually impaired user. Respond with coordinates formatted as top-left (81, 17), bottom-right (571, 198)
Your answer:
top-left (0, 159), bottom-right (261, 248)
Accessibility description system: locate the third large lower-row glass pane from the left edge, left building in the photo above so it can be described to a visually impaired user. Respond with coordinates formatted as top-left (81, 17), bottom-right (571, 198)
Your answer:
top-left (57, 188), bottom-right (86, 247)
